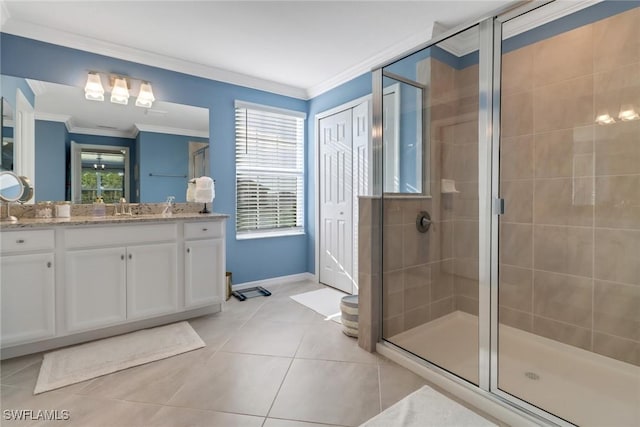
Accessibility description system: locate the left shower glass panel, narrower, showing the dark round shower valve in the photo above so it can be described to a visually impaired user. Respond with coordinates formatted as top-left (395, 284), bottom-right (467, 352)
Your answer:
top-left (382, 26), bottom-right (479, 384)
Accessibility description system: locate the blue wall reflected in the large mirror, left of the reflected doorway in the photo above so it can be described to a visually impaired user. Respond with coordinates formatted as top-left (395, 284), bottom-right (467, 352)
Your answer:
top-left (35, 120), bottom-right (68, 201)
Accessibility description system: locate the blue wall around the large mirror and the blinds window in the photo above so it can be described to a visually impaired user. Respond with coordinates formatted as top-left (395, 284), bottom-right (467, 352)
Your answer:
top-left (0, 33), bottom-right (308, 283)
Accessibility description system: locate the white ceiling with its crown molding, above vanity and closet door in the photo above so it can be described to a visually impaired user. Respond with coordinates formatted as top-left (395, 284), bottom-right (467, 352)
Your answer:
top-left (0, 0), bottom-right (514, 99)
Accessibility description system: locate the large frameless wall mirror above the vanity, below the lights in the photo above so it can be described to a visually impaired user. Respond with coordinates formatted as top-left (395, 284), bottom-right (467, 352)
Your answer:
top-left (1, 75), bottom-right (209, 203)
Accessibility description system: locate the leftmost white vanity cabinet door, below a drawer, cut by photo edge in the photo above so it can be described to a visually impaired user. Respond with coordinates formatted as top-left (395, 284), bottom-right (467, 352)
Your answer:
top-left (0, 254), bottom-right (55, 346)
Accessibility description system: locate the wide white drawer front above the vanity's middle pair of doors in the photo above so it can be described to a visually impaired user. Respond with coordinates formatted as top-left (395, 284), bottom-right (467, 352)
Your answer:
top-left (65, 223), bottom-right (178, 248)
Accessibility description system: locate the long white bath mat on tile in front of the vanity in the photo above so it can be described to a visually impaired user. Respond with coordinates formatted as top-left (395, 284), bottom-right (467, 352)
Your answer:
top-left (33, 322), bottom-right (206, 394)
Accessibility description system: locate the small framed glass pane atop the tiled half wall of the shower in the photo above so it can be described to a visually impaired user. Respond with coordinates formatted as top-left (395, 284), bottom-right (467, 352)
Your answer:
top-left (382, 71), bottom-right (430, 196)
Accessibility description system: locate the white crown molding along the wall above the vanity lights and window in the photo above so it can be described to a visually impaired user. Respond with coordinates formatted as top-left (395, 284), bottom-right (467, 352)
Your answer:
top-left (2, 19), bottom-right (307, 99)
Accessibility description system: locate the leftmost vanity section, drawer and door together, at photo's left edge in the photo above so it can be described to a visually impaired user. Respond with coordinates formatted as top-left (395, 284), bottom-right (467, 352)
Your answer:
top-left (0, 230), bottom-right (55, 347)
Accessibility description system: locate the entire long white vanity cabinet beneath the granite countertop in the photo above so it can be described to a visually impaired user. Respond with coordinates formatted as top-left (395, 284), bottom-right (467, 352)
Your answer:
top-left (0, 214), bottom-right (226, 359)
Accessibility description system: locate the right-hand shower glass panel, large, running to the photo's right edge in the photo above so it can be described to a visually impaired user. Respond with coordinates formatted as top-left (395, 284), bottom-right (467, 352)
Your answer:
top-left (498, 2), bottom-right (640, 426)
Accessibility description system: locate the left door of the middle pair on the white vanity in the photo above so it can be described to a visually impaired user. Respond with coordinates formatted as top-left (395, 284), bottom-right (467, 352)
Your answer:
top-left (65, 248), bottom-right (127, 331)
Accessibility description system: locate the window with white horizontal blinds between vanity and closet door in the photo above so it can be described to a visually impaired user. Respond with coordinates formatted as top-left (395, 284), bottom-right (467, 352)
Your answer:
top-left (235, 101), bottom-right (305, 239)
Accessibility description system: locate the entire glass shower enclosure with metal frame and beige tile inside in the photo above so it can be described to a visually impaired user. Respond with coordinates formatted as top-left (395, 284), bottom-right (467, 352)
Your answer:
top-left (374, 1), bottom-right (640, 426)
